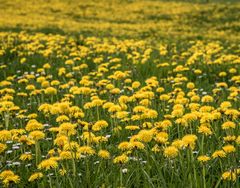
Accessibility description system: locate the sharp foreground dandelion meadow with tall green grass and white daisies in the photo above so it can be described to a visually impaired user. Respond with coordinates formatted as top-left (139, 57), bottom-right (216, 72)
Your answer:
top-left (0, 2), bottom-right (240, 188)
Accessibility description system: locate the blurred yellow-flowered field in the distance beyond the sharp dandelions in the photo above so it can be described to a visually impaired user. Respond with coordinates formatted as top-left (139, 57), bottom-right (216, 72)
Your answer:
top-left (0, 0), bottom-right (240, 41)
